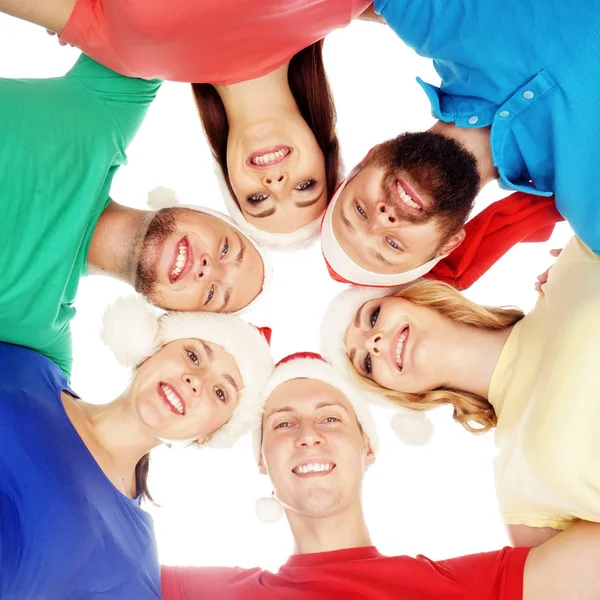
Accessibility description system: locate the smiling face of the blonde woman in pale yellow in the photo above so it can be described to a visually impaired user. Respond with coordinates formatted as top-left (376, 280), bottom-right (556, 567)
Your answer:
top-left (344, 296), bottom-right (455, 393)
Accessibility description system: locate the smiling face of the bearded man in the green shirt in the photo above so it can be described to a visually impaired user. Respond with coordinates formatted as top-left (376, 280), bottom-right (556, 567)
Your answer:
top-left (135, 208), bottom-right (264, 312)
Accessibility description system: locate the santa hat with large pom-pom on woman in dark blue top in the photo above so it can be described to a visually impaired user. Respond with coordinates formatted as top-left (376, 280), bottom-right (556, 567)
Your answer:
top-left (100, 296), bottom-right (273, 448)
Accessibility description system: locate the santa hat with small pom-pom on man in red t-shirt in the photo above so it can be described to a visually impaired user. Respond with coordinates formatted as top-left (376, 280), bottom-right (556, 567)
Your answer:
top-left (252, 352), bottom-right (379, 523)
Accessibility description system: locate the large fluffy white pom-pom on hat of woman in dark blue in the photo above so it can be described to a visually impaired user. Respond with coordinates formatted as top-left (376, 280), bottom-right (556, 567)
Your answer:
top-left (100, 296), bottom-right (158, 367)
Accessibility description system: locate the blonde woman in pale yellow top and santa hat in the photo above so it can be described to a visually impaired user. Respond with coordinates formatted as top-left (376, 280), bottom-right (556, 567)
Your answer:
top-left (323, 238), bottom-right (600, 545)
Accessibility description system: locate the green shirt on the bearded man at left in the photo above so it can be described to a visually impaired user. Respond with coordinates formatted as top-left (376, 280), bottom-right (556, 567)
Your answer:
top-left (0, 55), bottom-right (161, 377)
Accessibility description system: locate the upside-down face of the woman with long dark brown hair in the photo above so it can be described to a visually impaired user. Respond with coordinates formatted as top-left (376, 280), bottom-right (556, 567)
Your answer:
top-left (227, 113), bottom-right (328, 233)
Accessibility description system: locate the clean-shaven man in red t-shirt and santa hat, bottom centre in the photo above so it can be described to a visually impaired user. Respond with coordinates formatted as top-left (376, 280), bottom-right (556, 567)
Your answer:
top-left (162, 354), bottom-right (600, 600)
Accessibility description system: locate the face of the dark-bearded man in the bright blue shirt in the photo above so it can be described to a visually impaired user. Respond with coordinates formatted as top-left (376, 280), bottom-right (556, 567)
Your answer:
top-left (333, 132), bottom-right (479, 274)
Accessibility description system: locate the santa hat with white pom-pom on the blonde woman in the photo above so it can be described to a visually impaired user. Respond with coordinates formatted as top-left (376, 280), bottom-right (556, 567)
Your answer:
top-left (321, 284), bottom-right (433, 446)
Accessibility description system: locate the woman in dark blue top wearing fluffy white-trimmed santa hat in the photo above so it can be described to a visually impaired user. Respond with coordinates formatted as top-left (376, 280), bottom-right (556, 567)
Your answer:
top-left (0, 298), bottom-right (273, 600)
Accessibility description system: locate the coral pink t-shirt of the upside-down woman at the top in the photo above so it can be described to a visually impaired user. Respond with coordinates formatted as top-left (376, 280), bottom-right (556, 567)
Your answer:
top-left (61, 0), bottom-right (371, 85)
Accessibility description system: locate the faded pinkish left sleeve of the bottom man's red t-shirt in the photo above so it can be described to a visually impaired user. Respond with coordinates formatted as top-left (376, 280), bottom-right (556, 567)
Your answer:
top-left (161, 566), bottom-right (262, 600)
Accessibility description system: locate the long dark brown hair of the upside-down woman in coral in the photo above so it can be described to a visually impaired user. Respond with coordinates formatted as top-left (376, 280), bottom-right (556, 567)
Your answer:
top-left (192, 40), bottom-right (340, 205)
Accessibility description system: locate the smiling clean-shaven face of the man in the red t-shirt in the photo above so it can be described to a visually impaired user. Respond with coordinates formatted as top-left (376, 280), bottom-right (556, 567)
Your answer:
top-left (259, 379), bottom-right (373, 518)
